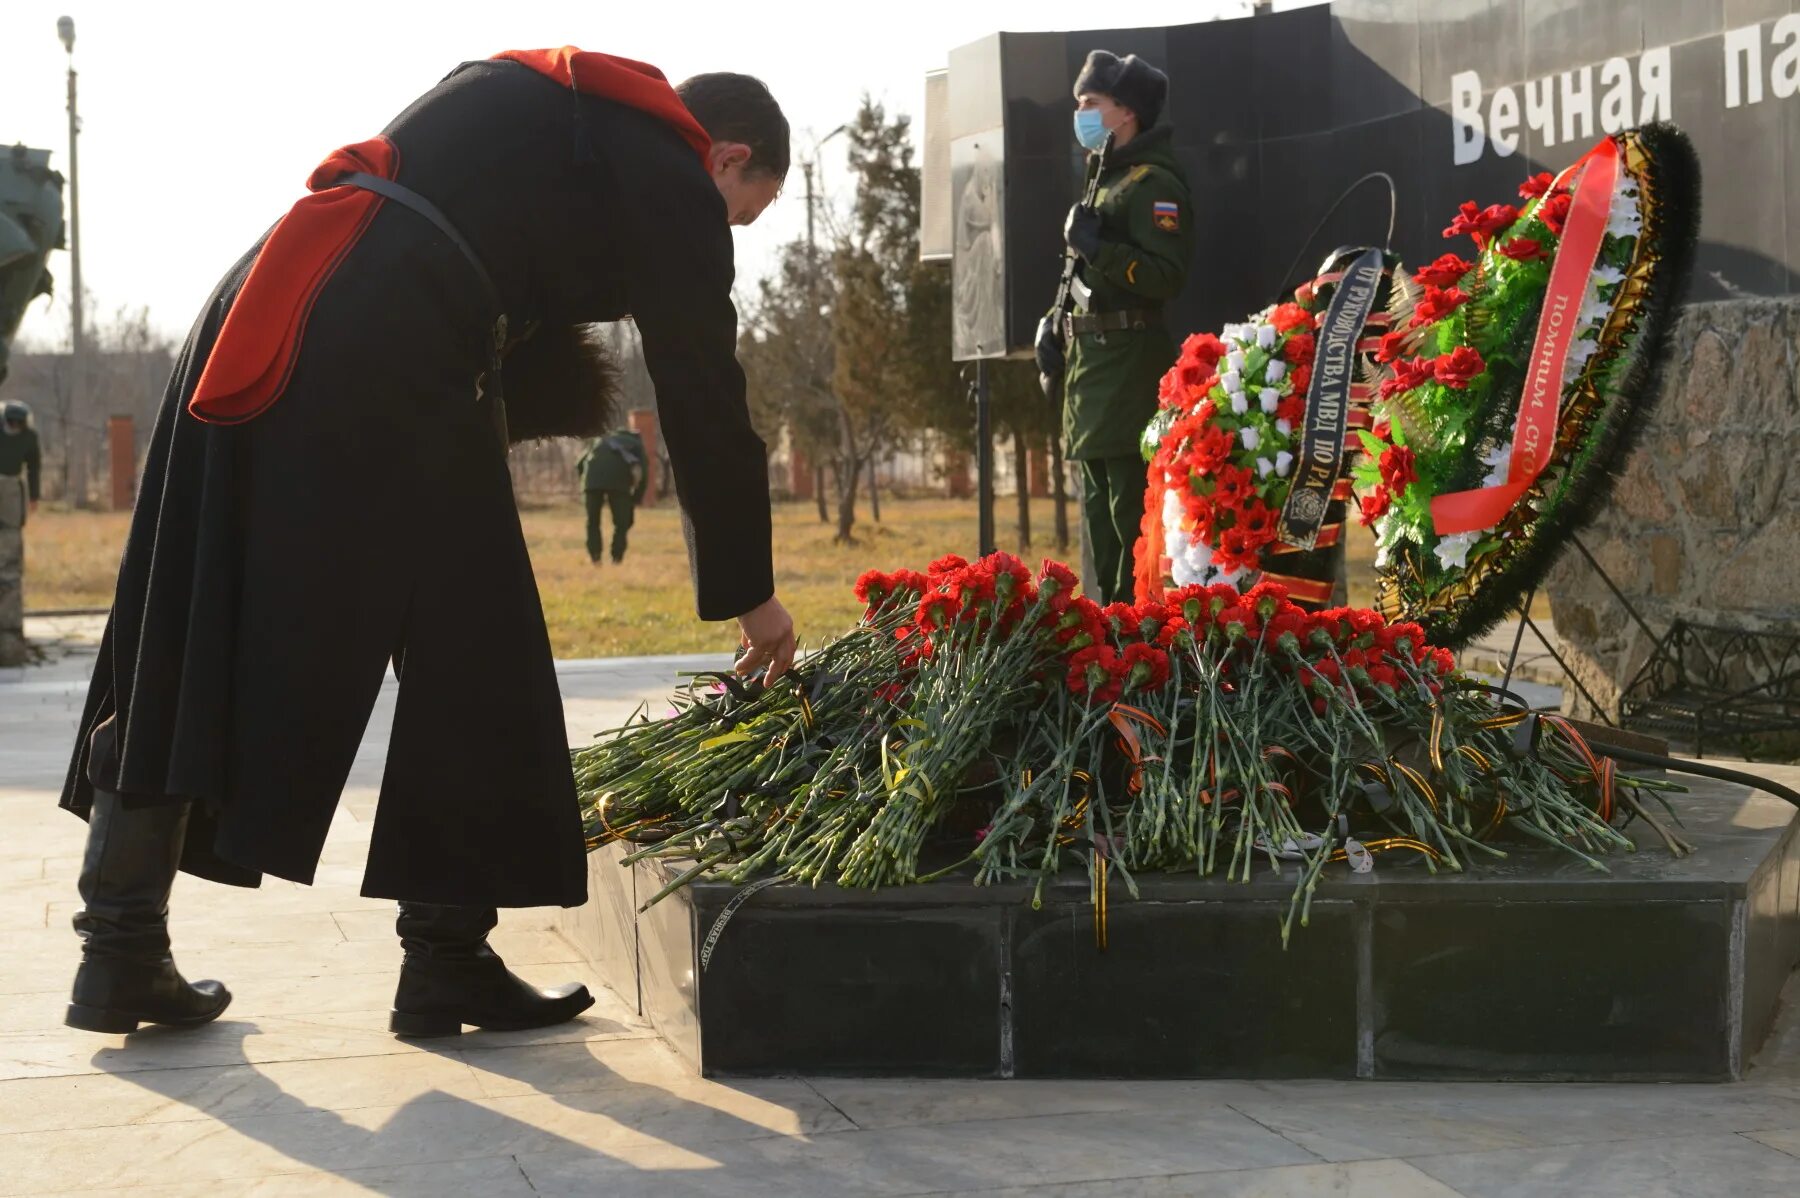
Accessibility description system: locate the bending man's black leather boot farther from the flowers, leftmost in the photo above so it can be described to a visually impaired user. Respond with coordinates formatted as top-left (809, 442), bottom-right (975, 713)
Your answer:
top-left (63, 791), bottom-right (230, 1034)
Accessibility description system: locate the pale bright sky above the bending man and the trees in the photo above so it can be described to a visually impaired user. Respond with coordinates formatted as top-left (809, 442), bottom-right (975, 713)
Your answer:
top-left (0, 0), bottom-right (1247, 340)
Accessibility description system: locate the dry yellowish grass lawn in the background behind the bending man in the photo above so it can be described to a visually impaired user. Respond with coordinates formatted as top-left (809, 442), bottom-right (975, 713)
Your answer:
top-left (25, 496), bottom-right (1396, 658)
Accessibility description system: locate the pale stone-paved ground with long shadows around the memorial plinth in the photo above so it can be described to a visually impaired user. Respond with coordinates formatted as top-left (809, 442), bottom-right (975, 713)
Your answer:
top-left (0, 637), bottom-right (1800, 1198)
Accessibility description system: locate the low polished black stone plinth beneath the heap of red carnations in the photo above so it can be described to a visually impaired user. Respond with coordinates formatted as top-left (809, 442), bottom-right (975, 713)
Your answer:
top-left (562, 779), bottom-right (1800, 1081)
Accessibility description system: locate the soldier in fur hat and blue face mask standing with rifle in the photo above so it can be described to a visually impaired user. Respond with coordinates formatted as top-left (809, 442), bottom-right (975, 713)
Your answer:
top-left (1037, 50), bottom-right (1193, 603)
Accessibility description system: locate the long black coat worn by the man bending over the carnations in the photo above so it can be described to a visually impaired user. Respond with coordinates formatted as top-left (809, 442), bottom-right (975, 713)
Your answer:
top-left (63, 50), bottom-right (774, 907)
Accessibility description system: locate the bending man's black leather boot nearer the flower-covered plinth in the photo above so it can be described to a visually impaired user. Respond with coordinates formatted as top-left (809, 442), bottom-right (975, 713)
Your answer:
top-left (387, 903), bottom-right (594, 1036)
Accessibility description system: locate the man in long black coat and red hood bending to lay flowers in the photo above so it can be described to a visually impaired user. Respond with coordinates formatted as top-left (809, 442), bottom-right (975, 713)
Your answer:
top-left (61, 47), bottom-right (794, 1034)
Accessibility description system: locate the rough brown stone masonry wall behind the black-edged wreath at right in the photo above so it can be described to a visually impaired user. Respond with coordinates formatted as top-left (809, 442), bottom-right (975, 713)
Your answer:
top-left (1548, 299), bottom-right (1800, 714)
